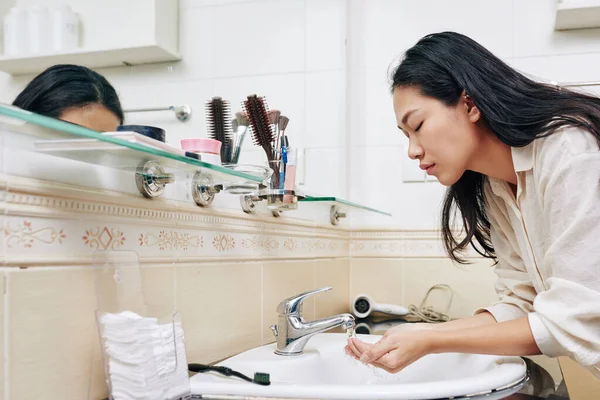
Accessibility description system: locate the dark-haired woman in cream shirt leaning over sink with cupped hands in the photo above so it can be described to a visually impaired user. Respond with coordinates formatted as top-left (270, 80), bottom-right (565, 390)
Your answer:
top-left (346, 32), bottom-right (600, 378)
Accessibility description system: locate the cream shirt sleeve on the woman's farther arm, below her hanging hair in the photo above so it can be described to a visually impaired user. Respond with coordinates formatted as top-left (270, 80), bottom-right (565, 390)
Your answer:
top-left (474, 182), bottom-right (536, 322)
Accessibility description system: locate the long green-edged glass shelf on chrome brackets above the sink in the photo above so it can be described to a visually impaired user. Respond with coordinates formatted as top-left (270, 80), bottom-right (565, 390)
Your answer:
top-left (0, 103), bottom-right (391, 216)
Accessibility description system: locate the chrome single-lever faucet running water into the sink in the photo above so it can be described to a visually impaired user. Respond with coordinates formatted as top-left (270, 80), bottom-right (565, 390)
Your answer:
top-left (271, 286), bottom-right (354, 356)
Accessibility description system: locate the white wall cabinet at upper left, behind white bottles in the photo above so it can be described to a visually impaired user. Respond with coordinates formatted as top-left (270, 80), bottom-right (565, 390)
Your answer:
top-left (0, 0), bottom-right (181, 75)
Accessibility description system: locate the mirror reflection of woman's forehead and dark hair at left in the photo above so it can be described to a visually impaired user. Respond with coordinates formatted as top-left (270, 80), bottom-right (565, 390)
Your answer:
top-left (13, 65), bottom-right (124, 132)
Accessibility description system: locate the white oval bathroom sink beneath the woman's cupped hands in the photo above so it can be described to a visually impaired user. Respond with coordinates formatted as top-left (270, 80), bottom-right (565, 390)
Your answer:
top-left (191, 333), bottom-right (527, 400)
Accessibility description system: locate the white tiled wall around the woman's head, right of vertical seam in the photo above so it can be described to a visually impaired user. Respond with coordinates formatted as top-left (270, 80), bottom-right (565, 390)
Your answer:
top-left (348, 0), bottom-right (600, 229)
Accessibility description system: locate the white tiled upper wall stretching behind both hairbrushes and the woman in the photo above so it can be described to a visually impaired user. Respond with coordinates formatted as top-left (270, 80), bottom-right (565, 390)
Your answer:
top-left (0, 0), bottom-right (600, 228)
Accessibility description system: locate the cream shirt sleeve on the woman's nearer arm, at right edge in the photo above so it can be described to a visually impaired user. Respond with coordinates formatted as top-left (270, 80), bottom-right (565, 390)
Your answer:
top-left (528, 144), bottom-right (600, 376)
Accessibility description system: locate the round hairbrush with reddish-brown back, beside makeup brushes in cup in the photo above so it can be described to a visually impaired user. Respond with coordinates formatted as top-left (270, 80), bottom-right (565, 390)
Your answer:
top-left (242, 94), bottom-right (279, 188)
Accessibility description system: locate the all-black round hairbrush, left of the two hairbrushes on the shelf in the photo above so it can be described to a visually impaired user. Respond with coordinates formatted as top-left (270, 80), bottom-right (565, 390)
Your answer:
top-left (206, 97), bottom-right (233, 164)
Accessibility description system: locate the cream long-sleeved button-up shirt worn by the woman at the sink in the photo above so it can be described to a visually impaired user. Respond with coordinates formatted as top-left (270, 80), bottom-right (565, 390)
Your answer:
top-left (475, 128), bottom-right (600, 378)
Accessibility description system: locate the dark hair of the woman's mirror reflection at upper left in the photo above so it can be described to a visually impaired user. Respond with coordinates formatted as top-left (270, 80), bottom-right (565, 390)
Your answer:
top-left (13, 64), bottom-right (124, 124)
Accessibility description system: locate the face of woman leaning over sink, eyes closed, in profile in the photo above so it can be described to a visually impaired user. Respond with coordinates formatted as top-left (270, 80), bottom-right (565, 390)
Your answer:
top-left (394, 87), bottom-right (480, 186)
